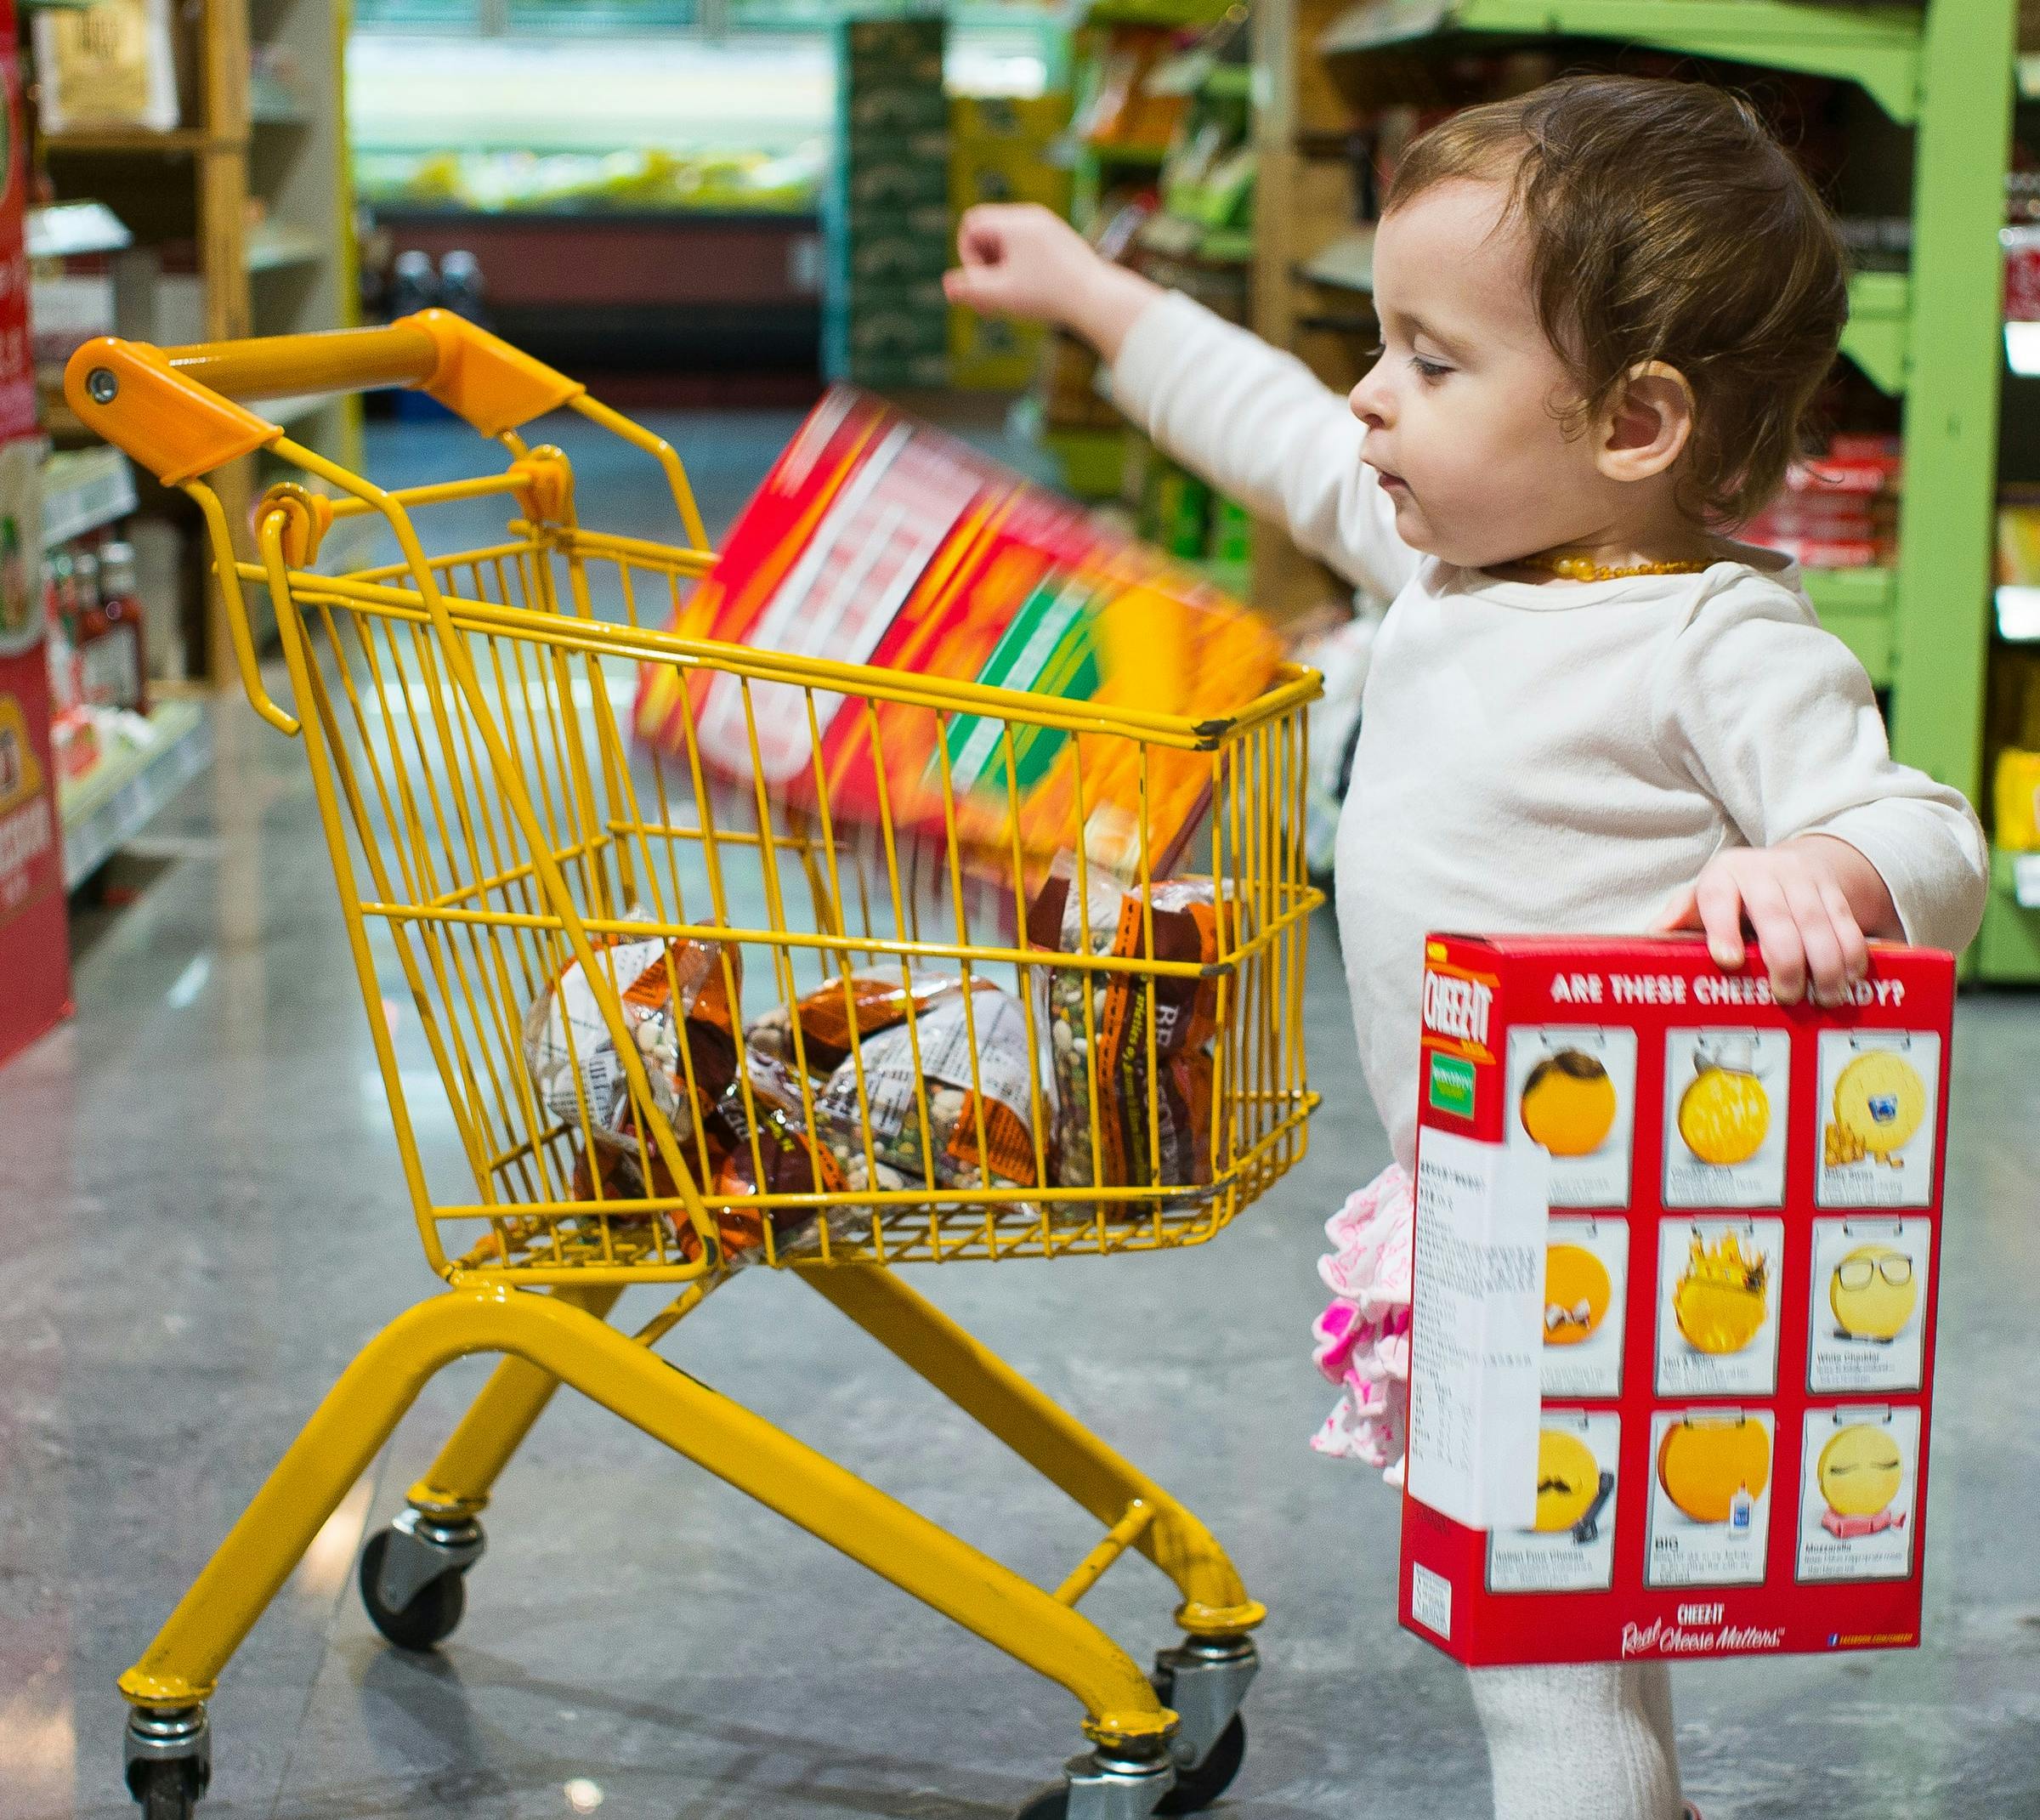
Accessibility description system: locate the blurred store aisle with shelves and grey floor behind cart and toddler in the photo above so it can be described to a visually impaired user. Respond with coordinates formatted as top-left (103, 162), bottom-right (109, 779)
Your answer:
top-left (12, 0), bottom-right (2040, 1820)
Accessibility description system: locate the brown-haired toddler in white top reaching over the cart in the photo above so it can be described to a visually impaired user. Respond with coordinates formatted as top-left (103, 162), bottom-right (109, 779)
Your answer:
top-left (949, 76), bottom-right (1987, 1820)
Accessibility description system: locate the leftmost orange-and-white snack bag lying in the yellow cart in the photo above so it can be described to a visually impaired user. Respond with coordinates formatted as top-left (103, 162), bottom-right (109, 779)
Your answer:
top-left (524, 912), bottom-right (743, 1163)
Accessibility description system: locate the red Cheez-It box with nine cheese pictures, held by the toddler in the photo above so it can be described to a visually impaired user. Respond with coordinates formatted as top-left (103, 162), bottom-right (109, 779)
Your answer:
top-left (1399, 937), bottom-right (1954, 1667)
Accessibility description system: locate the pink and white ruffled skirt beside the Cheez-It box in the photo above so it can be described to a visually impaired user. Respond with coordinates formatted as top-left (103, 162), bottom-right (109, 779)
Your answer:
top-left (1310, 1163), bottom-right (1416, 1485)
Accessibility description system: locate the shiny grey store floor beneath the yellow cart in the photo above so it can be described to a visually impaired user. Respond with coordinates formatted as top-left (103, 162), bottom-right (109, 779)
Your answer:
top-left (0, 417), bottom-right (2040, 1820)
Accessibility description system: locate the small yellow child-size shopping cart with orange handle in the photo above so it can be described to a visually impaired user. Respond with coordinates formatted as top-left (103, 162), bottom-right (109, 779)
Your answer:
top-left (67, 312), bottom-right (1318, 1820)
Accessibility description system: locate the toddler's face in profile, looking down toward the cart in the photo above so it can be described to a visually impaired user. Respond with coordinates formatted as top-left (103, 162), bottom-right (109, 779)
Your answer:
top-left (1352, 179), bottom-right (1624, 570)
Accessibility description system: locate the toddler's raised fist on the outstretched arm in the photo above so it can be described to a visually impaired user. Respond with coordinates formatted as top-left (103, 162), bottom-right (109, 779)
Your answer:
top-left (943, 202), bottom-right (1161, 361)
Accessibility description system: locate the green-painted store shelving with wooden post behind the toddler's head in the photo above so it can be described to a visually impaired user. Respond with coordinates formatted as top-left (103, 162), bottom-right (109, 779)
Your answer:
top-left (1255, 0), bottom-right (2040, 979)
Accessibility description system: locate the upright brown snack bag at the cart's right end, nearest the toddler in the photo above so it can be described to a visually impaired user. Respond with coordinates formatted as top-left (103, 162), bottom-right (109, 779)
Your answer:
top-left (1028, 863), bottom-right (1224, 1188)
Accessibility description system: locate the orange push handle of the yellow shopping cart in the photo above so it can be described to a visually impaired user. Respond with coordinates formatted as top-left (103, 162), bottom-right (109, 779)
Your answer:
top-left (63, 310), bottom-right (587, 485)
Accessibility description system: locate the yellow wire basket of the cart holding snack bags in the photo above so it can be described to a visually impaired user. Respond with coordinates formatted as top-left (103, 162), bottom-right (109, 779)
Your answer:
top-left (67, 318), bottom-right (1318, 1284)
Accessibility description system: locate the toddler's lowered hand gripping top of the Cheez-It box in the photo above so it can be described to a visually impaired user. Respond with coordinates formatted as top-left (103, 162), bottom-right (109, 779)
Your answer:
top-left (1657, 835), bottom-right (1903, 1004)
